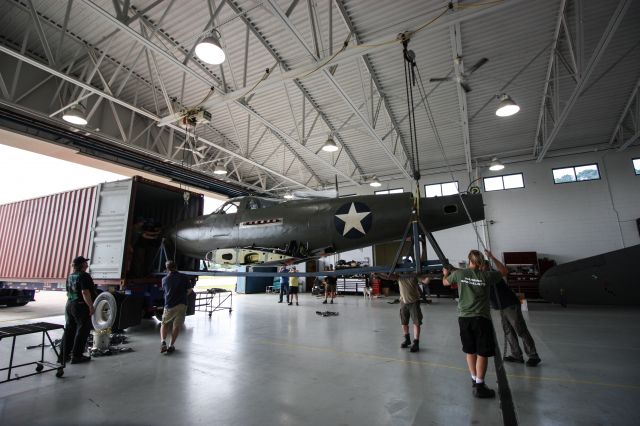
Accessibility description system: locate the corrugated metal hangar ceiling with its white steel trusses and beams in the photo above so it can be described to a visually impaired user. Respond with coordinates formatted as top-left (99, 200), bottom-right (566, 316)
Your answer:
top-left (0, 0), bottom-right (640, 195)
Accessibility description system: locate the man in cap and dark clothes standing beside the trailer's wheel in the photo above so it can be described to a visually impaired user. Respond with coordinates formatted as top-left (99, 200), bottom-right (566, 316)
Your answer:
top-left (62, 256), bottom-right (96, 364)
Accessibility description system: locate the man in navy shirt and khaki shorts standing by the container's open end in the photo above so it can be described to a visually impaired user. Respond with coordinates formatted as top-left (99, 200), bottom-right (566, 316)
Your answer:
top-left (160, 260), bottom-right (193, 353)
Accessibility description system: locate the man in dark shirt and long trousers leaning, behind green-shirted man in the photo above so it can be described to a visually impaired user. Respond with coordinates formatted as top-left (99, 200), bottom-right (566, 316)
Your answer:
top-left (482, 262), bottom-right (540, 367)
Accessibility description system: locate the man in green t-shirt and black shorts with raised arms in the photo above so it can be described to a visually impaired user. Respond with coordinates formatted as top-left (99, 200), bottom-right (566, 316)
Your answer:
top-left (442, 250), bottom-right (508, 398)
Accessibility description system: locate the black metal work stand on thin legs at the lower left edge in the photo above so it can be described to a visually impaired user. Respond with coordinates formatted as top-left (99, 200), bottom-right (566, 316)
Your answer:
top-left (0, 322), bottom-right (65, 383)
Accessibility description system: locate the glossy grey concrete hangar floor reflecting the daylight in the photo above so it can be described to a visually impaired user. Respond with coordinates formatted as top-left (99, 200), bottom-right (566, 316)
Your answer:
top-left (0, 294), bottom-right (640, 426)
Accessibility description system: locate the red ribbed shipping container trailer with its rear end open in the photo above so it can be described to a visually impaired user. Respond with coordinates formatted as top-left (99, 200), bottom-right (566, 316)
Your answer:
top-left (0, 176), bottom-right (204, 329)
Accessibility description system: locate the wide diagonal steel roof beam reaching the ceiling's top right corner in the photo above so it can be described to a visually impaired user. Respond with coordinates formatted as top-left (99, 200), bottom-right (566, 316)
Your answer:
top-left (536, 0), bottom-right (632, 162)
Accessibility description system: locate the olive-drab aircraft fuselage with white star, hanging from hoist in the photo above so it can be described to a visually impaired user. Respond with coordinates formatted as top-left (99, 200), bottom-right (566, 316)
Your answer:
top-left (167, 193), bottom-right (484, 264)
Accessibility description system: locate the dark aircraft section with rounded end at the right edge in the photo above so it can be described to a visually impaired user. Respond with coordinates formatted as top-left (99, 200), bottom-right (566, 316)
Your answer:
top-left (540, 244), bottom-right (640, 305)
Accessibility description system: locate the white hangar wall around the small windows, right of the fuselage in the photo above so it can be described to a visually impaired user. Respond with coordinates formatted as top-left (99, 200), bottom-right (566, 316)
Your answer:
top-left (340, 147), bottom-right (640, 265)
